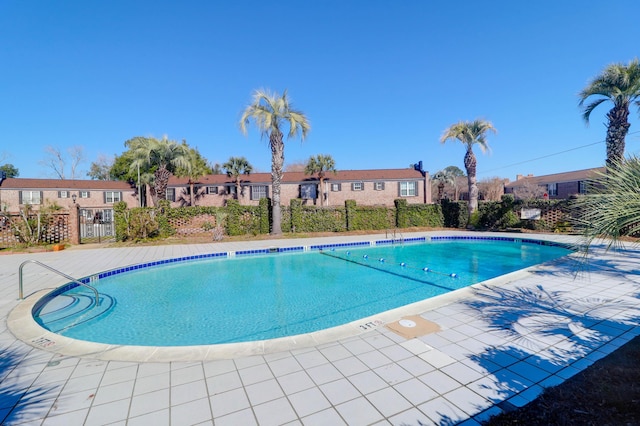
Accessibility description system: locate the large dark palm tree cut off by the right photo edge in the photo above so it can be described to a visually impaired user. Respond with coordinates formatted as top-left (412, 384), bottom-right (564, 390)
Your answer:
top-left (579, 59), bottom-right (640, 168)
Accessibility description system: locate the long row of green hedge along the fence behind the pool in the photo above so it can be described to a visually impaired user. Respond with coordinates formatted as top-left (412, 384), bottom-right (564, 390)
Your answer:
top-left (114, 196), bottom-right (566, 241)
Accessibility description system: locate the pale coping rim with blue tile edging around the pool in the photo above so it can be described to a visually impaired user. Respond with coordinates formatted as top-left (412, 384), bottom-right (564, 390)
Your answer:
top-left (7, 235), bottom-right (571, 362)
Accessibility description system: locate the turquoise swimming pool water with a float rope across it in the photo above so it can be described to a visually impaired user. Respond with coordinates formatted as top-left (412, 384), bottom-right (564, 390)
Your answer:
top-left (34, 239), bottom-right (570, 346)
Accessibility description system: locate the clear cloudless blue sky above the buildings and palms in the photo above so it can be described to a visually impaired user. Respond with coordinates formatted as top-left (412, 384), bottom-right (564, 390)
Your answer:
top-left (0, 0), bottom-right (640, 180)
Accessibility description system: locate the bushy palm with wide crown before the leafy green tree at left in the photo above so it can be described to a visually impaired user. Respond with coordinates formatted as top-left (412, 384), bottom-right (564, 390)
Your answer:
top-left (127, 136), bottom-right (189, 205)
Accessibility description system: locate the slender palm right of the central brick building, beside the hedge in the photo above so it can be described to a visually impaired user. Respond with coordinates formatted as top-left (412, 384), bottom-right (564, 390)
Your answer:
top-left (440, 119), bottom-right (496, 217)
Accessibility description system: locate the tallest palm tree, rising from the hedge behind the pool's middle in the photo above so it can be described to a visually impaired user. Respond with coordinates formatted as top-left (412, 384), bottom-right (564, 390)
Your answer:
top-left (240, 90), bottom-right (311, 235)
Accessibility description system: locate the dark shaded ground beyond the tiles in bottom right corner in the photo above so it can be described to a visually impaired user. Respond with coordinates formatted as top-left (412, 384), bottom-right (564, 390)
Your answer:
top-left (486, 336), bottom-right (640, 426)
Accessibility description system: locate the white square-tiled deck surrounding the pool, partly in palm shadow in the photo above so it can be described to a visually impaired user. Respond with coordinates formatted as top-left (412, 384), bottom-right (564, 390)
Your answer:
top-left (0, 231), bottom-right (640, 426)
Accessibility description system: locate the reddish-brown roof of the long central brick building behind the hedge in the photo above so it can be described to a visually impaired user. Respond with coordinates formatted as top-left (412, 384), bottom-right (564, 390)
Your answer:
top-left (169, 168), bottom-right (423, 186)
